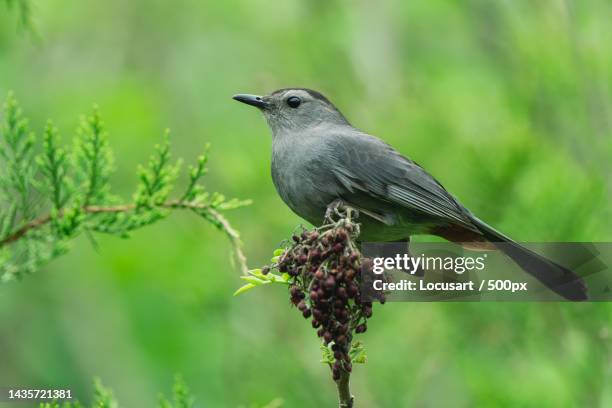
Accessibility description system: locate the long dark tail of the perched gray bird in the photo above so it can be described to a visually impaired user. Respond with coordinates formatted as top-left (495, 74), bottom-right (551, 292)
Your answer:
top-left (473, 217), bottom-right (588, 301)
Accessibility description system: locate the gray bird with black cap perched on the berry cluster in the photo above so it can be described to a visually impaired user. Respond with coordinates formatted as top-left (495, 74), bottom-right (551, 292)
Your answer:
top-left (233, 88), bottom-right (588, 301)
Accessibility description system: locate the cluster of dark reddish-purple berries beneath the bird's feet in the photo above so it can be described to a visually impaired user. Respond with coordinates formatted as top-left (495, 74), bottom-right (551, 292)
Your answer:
top-left (268, 219), bottom-right (384, 380)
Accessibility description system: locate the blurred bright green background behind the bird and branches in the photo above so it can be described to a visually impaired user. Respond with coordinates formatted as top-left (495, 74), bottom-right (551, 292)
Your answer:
top-left (0, 0), bottom-right (612, 407)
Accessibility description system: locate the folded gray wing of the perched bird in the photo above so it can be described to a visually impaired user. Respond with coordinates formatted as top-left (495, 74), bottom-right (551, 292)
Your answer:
top-left (326, 133), bottom-right (477, 230)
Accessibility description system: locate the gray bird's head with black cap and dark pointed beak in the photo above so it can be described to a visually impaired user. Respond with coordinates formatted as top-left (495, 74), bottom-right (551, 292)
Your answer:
top-left (234, 88), bottom-right (348, 134)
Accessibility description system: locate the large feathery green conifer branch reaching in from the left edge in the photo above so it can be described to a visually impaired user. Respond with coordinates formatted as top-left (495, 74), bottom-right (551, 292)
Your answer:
top-left (0, 95), bottom-right (248, 281)
